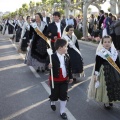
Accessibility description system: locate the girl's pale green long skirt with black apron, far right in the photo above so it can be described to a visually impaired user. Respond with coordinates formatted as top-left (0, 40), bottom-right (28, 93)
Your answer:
top-left (95, 64), bottom-right (120, 103)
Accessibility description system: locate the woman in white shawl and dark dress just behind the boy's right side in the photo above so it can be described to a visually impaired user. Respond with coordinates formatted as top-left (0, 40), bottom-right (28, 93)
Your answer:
top-left (62, 25), bottom-right (83, 80)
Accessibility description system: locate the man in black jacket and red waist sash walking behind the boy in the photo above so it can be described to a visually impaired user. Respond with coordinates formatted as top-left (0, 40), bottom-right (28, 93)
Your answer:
top-left (47, 12), bottom-right (65, 52)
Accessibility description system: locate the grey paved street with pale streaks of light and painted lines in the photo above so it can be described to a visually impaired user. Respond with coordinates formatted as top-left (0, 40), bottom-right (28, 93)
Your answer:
top-left (0, 35), bottom-right (120, 120)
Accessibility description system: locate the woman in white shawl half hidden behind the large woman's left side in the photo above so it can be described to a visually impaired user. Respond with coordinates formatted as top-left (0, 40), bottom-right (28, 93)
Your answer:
top-left (18, 16), bottom-right (30, 52)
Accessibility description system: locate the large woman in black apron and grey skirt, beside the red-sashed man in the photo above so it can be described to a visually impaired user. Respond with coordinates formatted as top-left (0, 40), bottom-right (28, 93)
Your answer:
top-left (26, 13), bottom-right (48, 72)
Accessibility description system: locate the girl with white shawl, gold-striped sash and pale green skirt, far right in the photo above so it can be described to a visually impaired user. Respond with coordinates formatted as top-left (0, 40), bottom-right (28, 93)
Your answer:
top-left (88, 36), bottom-right (120, 109)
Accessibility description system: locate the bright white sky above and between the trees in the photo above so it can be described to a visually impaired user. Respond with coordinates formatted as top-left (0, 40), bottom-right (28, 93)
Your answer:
top-left (0, 0), bottom-right (109, 12)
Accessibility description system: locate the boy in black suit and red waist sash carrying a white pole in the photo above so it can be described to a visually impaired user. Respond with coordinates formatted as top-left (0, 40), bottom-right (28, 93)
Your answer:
top-left (48, 39), bottom-right (73, 119)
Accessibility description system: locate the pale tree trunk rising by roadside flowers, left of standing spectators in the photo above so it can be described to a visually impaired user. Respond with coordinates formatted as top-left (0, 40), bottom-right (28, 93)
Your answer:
top-left (83, 3), bottom-right (90, 38)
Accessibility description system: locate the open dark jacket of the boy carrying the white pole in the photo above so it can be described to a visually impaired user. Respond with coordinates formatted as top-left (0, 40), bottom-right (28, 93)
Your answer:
top-left (48, 52), bottom-right (73, 79)
